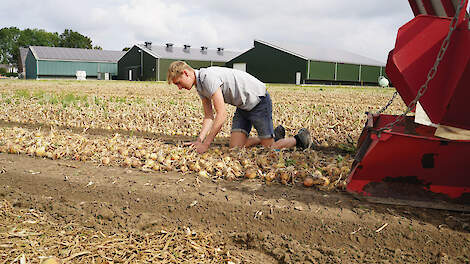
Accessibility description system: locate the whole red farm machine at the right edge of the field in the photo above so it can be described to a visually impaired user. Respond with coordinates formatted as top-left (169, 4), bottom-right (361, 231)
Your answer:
top-left (347, 0), bottom-right (470, 211)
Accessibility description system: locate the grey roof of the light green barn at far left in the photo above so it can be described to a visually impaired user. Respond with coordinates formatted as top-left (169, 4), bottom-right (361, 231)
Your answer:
top-left (29, 46), bottom-right (126, 63)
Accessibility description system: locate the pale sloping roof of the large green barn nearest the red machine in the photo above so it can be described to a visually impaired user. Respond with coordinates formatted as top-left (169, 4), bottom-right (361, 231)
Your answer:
top-left (255, 40), bottom-right (385, 66)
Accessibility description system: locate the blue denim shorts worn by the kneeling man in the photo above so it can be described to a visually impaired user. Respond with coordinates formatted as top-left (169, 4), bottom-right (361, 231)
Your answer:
top-left (232, 92), bottom-right (274, 139)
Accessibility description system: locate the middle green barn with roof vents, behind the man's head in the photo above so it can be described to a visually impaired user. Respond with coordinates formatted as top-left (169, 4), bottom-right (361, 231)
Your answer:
top-left (118, 42), bottom-right (241, 81)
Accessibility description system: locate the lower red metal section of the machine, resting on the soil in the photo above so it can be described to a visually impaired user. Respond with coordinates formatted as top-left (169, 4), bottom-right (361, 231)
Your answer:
top-left (347, 114), bottom-right (470, 203)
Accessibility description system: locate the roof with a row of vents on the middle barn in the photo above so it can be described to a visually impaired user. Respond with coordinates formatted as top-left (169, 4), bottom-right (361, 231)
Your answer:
top-left (136, 44), bottom-right (242, 62)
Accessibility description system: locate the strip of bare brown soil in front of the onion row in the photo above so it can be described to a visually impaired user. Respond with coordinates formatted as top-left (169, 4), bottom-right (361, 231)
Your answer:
top-left (0, 154), bottom-right (470, 263)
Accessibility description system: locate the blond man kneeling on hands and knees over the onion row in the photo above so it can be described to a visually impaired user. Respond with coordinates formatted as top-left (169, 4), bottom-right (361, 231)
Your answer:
top-left (167, 61), bottom-right (311, 153)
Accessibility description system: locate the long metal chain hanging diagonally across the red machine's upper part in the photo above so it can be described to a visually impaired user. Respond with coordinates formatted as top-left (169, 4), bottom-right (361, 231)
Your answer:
top-left (377, 0), bottom-right (464, 135)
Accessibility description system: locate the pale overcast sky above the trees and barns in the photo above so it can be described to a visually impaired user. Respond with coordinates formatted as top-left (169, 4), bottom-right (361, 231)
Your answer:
top-left (0, 0), bottom-right (413, 62)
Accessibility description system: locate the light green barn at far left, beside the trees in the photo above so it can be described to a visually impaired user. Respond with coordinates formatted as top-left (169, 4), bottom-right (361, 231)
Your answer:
top-left (25, 46), bottom-right (125, 79)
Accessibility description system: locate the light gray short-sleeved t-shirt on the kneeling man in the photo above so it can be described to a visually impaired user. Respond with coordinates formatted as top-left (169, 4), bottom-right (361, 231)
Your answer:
top-left (195, 67), bottom-right (266, 111)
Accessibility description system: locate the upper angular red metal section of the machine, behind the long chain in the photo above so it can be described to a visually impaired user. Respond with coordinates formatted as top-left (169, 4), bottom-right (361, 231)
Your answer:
top-left (386, 0), bottom-right (470, 129)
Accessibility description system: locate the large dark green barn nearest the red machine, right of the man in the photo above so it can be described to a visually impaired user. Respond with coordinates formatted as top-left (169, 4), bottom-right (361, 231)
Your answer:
top-left (226, 40), bottom-right (385, 85)
